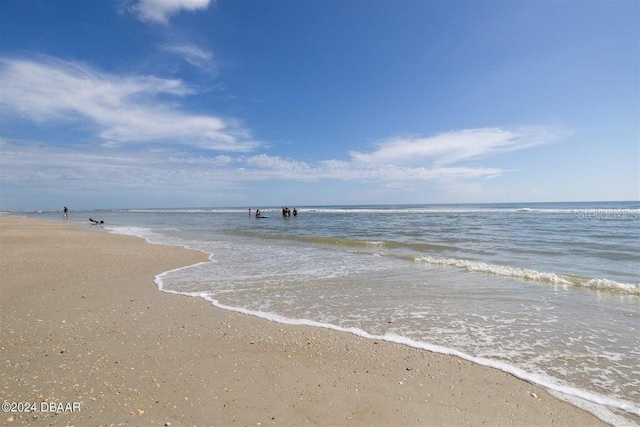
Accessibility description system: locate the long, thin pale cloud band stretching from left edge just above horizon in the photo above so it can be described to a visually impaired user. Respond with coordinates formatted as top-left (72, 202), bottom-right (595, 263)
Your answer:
top-left (0, 141), bottom-right (504, 197)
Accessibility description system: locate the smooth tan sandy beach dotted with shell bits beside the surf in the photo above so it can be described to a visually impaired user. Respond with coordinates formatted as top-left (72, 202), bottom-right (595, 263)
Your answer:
top-left (0, 217), bottom-right (603, 426)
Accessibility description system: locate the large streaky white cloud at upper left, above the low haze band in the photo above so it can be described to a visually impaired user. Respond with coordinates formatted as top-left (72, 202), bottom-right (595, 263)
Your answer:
top-left (0, 57), bottom-right (259, 152)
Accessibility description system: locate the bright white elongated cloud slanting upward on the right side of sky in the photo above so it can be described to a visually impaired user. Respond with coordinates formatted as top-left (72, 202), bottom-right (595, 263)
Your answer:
top-left (351, 128), bottom-right (558, 165)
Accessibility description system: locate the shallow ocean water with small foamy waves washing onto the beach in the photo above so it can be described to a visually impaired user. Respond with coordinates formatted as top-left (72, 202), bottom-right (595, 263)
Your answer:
top-left (11, 202), bottom-right (640, 425)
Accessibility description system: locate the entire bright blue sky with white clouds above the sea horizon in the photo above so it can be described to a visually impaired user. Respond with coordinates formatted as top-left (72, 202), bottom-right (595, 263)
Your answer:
top-left (0, 0), bottom-right (640, 209)
